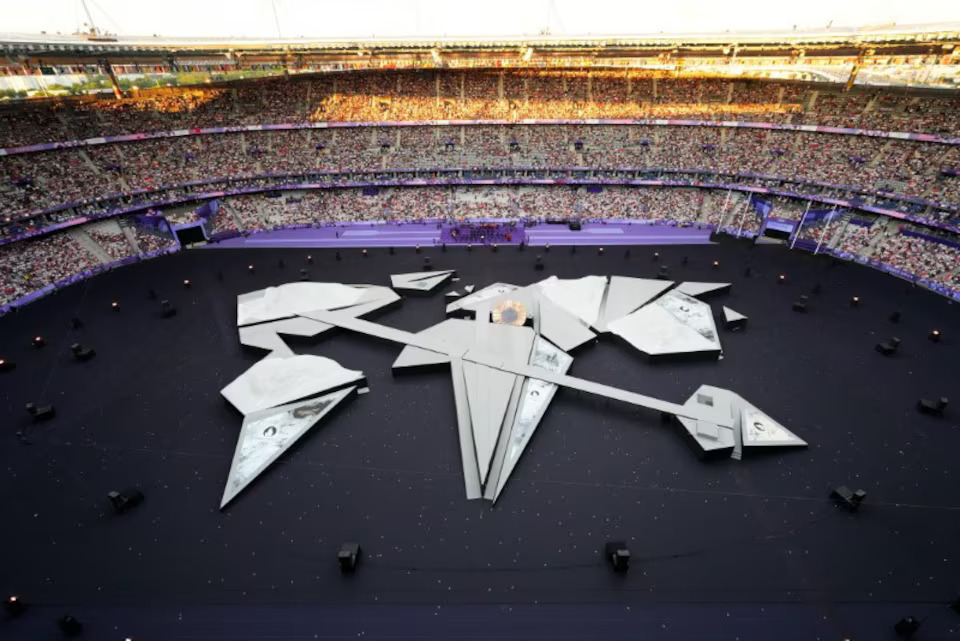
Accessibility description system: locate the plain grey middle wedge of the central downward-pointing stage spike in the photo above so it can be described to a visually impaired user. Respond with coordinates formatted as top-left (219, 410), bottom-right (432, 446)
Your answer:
top-left (463, 362), bottom-right (516, 483)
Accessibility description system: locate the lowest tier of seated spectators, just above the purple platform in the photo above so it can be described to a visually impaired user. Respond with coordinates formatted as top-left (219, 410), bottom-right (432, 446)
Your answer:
top-left (0, 186), bottom-right (960, 303)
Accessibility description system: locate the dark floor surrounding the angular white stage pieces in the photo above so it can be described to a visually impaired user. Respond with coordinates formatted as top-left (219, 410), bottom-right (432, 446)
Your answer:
top-left (0, 241), bottom-right (960, 640)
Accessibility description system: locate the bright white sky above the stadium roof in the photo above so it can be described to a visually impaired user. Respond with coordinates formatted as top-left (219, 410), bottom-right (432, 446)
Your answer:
top-left (0, 0), bottom-right (960, 38)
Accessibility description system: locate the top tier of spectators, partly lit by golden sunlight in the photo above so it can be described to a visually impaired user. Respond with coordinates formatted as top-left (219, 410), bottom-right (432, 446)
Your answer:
top-left (0, 70), bottom-right (960, 147)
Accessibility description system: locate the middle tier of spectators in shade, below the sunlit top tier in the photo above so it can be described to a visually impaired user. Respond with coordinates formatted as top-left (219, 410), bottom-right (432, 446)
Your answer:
top-left (0, 125), bottom-right (960, 226)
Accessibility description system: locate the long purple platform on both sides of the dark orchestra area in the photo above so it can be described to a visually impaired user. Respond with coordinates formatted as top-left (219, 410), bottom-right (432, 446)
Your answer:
top-left (209, 223), bottom-right (710, 248)
